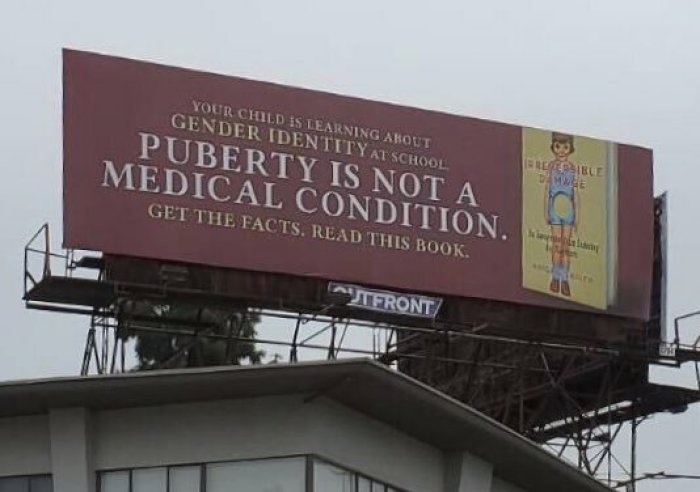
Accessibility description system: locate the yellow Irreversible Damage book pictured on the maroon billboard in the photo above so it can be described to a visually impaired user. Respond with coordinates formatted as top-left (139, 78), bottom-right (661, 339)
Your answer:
top-left (522, 128), bottom-right (618, 310)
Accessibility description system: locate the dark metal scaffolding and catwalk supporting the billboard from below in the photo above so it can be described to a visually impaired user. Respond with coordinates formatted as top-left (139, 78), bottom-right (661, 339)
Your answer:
top-left (24, 225), bottom-right (700, 491)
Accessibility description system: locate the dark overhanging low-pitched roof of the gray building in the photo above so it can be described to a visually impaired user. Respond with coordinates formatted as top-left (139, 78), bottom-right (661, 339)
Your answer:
top-left (0, 359), bottom-right (610, 492)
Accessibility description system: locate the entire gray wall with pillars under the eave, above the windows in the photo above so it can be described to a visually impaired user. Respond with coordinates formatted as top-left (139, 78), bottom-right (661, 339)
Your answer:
top-left (0, 396), bottom-right (525, 492)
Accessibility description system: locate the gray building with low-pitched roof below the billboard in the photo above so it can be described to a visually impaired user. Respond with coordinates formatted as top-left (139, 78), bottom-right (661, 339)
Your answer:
top-left (0, 359), bottom-right (610, 492)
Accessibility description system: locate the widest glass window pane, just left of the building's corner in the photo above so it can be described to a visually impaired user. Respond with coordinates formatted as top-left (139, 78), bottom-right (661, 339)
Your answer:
top-left (206, 458), bottom-right (306, 492)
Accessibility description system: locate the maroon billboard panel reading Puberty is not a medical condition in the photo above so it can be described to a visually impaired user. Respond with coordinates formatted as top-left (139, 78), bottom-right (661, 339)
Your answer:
top-left (64, 50), bottom-right (653, 319)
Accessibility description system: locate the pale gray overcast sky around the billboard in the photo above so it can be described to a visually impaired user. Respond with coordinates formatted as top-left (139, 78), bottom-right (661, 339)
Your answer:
top-left (0, 0), bottom-right (700, 492)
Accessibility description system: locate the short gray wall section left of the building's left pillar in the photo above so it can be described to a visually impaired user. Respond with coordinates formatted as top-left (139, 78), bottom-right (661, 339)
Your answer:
top-left (0, 415), bottom-right (51, 477)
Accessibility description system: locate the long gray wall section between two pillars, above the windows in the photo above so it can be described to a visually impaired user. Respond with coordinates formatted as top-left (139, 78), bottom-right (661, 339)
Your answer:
top-left (94, 396), bottom-right (442, 492)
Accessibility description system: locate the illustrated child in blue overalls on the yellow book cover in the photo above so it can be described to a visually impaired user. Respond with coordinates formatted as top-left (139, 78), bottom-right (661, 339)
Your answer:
top-left (544, 132), bottom-right (580, 297)
